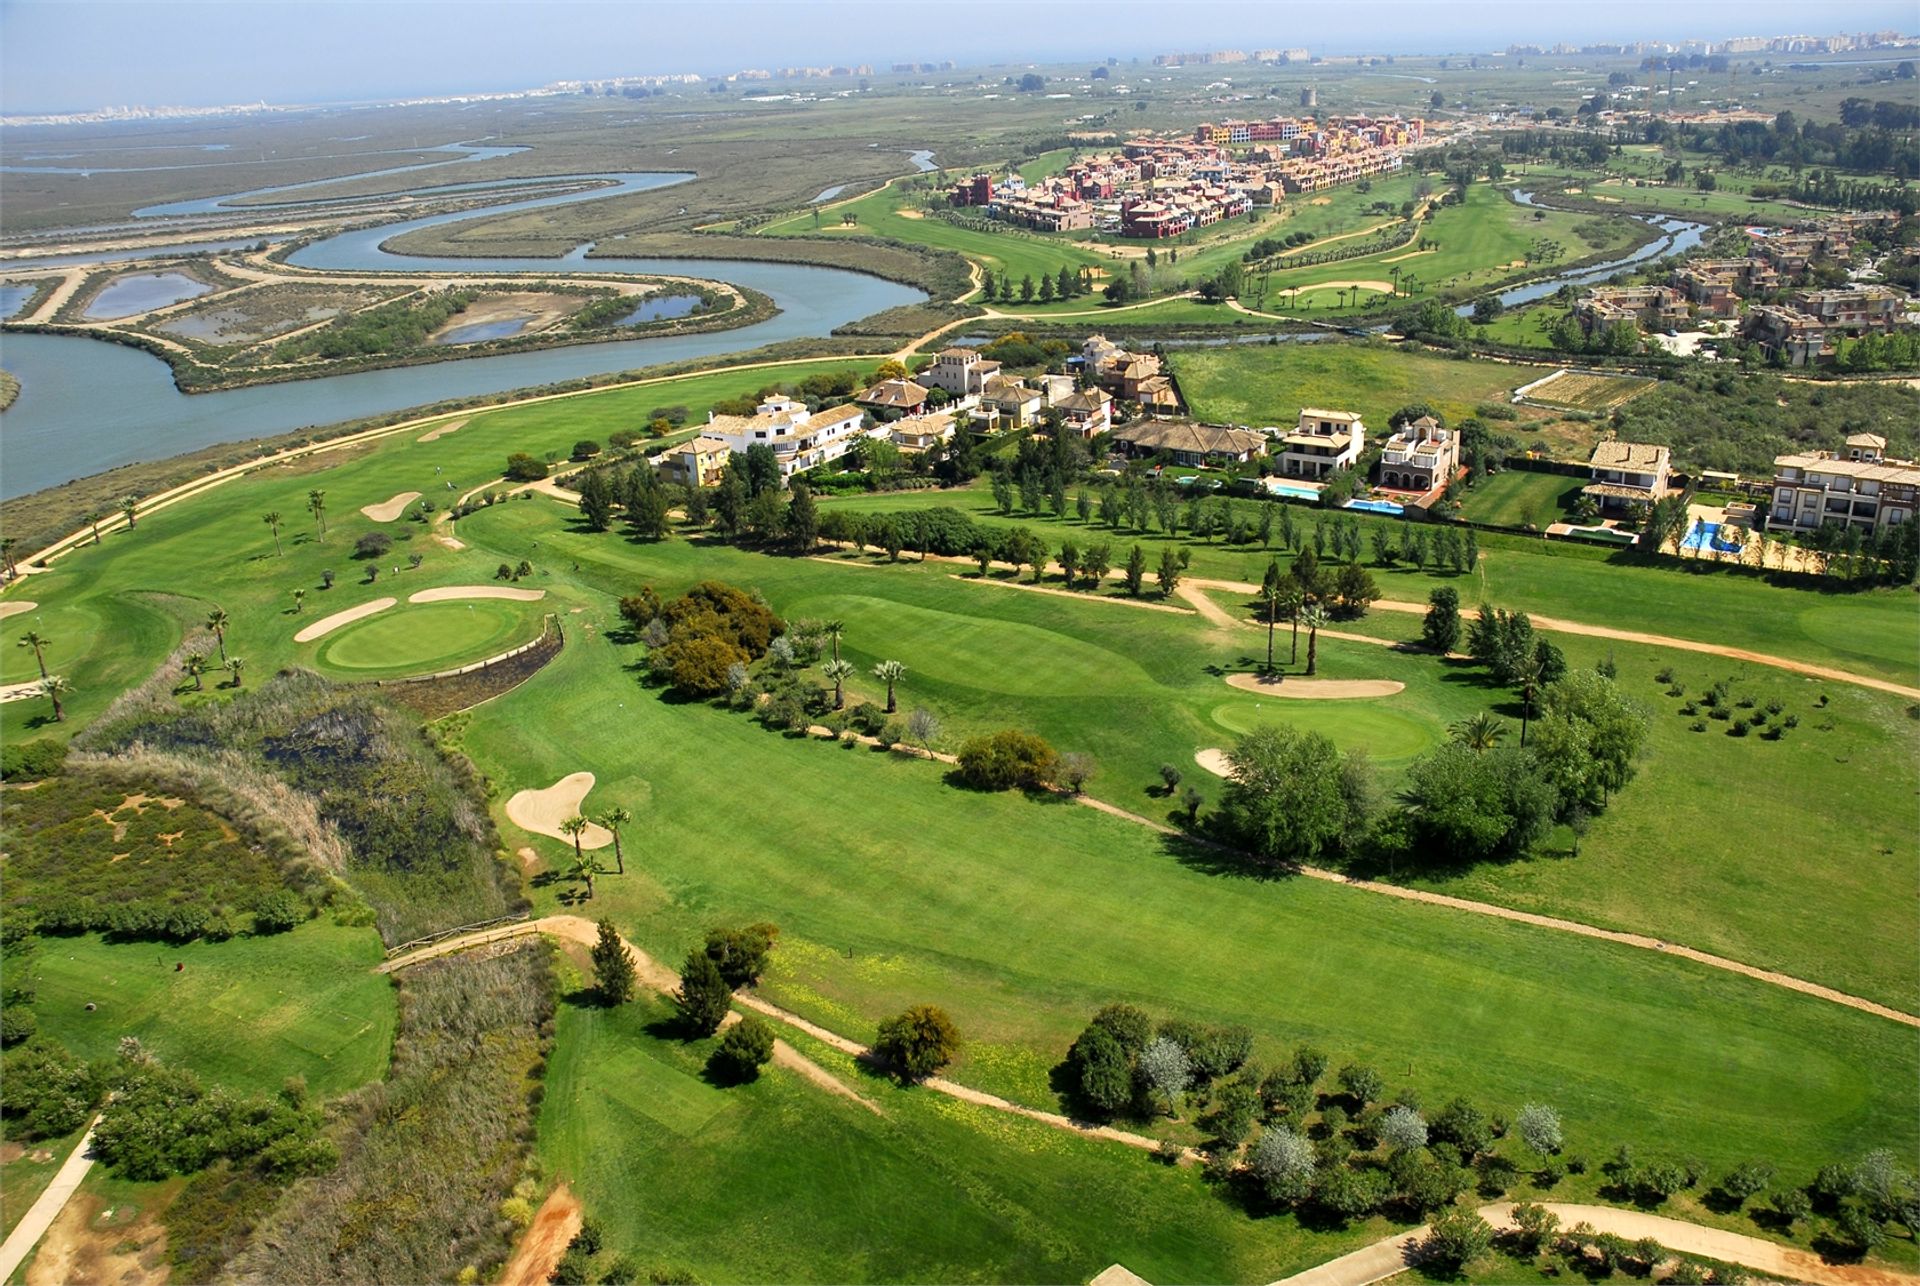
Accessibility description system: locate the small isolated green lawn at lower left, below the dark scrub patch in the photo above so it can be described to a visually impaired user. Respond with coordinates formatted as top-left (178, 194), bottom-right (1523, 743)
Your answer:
top-left (33, 919), bottom-right (394, 1098)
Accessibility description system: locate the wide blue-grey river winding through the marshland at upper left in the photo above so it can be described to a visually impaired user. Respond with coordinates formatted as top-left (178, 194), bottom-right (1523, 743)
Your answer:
top-left (0, 162), bottom-right (925, 499)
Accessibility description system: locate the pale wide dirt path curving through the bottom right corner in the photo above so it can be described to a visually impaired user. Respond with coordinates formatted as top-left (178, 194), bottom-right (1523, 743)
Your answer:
top-left (1273, 1202), bottom-right (1920, 1286)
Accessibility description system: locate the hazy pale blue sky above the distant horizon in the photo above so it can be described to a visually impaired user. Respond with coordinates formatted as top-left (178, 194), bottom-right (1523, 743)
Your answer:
top-left (0, 0), bottom-right (1914, 113)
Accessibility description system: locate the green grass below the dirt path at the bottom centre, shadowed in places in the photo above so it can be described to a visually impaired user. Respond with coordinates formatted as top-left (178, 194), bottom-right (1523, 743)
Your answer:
top-left (540, 998), bottom-right (1390, 1282)
